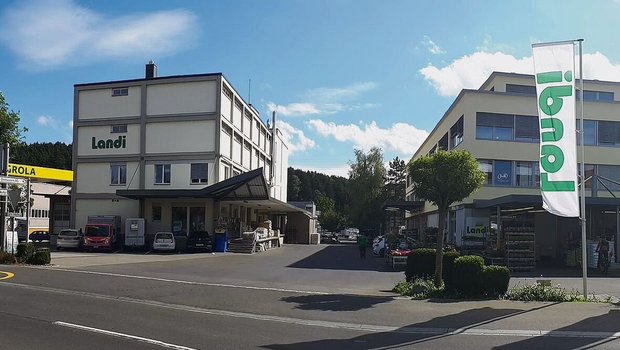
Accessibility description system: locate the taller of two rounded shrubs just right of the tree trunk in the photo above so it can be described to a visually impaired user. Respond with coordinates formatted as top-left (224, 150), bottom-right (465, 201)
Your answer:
top-left (452, 255), bottom-right (484, 297)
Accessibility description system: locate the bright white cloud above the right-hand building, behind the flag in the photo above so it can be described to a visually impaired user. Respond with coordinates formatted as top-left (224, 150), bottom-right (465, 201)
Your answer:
top-left (420, 48), bottom-right (620, 96)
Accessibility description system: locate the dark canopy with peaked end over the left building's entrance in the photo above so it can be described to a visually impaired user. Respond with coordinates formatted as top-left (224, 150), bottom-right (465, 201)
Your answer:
top-left (116, 168), bottom-right (269, 200)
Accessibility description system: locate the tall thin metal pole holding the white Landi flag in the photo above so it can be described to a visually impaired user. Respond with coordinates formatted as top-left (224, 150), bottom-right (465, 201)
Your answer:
top-left (577, 39), bottom-right (588, 299)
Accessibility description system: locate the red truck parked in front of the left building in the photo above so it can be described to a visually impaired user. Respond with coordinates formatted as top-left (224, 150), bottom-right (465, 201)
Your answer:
top-left (84, 215), bottom-right (121, 251)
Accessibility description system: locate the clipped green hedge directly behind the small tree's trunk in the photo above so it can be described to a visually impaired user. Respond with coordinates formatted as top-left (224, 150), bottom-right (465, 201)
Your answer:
top-left (405, 248), bottom-right (460, 286)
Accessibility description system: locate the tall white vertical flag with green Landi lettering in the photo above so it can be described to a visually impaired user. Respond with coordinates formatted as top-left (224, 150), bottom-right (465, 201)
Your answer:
top-left (533, 42), bottom-right (579, 217)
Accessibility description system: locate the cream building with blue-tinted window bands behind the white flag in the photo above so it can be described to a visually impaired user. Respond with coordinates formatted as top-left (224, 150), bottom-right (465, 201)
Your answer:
top-left (407, 72), bottom-right (620, 268)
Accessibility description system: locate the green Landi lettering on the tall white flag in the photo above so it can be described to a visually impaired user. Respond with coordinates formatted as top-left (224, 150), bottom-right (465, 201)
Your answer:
top-left (536, 70), bottom-right (575, 192)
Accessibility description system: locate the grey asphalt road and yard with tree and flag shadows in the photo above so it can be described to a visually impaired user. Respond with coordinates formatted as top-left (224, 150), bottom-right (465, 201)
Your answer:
top-left (0, 245), bottom-right (620, 350)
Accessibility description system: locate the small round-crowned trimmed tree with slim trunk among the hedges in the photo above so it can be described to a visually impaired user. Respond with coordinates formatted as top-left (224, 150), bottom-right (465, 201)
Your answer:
top-left (408, 151), bottom-right (485, 287)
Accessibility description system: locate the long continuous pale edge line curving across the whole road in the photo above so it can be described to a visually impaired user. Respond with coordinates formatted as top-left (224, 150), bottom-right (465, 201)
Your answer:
top-left (2, 283), bottom-right (620, 340)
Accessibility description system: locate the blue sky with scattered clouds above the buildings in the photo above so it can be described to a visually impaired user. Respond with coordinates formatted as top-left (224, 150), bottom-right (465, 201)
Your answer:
top-left (0, 0), bottom-right (620, 176)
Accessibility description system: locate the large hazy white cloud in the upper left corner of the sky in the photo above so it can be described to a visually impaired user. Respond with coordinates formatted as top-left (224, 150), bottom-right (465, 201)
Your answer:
top-left (0, 0), bottom-right (197, 69)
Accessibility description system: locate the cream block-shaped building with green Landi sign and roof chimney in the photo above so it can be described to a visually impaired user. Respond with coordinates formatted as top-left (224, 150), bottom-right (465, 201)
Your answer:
top-left (71, 62), bottom-right (309, 245)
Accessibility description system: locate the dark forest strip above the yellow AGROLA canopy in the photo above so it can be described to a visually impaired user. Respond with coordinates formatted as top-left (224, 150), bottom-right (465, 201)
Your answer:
top-left (11, 142), bottom-right (72, 170)
